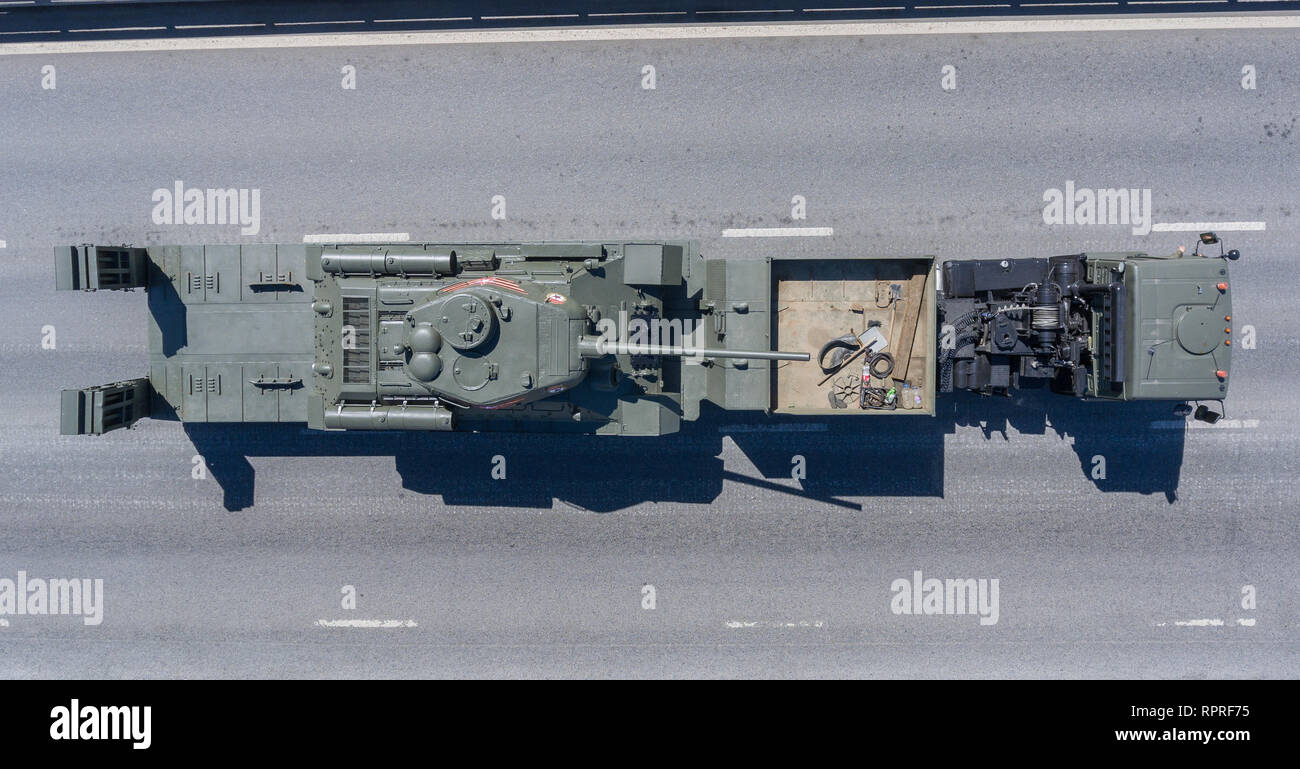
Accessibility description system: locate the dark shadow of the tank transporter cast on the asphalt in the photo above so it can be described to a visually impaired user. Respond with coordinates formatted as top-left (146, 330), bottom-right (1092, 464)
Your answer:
top-left (185, 391), bottom-right (1184, 513)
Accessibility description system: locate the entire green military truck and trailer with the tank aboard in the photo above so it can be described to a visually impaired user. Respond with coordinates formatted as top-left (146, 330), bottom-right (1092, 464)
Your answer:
top-left (56, 240), bottom-right (1235, 435)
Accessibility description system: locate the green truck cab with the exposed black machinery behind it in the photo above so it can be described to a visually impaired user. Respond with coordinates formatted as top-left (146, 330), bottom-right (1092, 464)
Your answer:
top-left (939, 242), bottom-right (1238, 410)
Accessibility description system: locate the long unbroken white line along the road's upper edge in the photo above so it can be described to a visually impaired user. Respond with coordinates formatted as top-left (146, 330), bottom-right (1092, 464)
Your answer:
top-left (0, 14), bottom-right (1300, 56)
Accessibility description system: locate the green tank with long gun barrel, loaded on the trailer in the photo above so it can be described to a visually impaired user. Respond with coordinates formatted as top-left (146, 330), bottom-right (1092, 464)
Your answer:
top-left (308, 246), bottom-right (810, 430)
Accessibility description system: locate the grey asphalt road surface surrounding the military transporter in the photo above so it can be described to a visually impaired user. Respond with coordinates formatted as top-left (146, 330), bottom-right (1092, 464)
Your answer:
top-left (0, 19), bottom-right (1300, 678)
